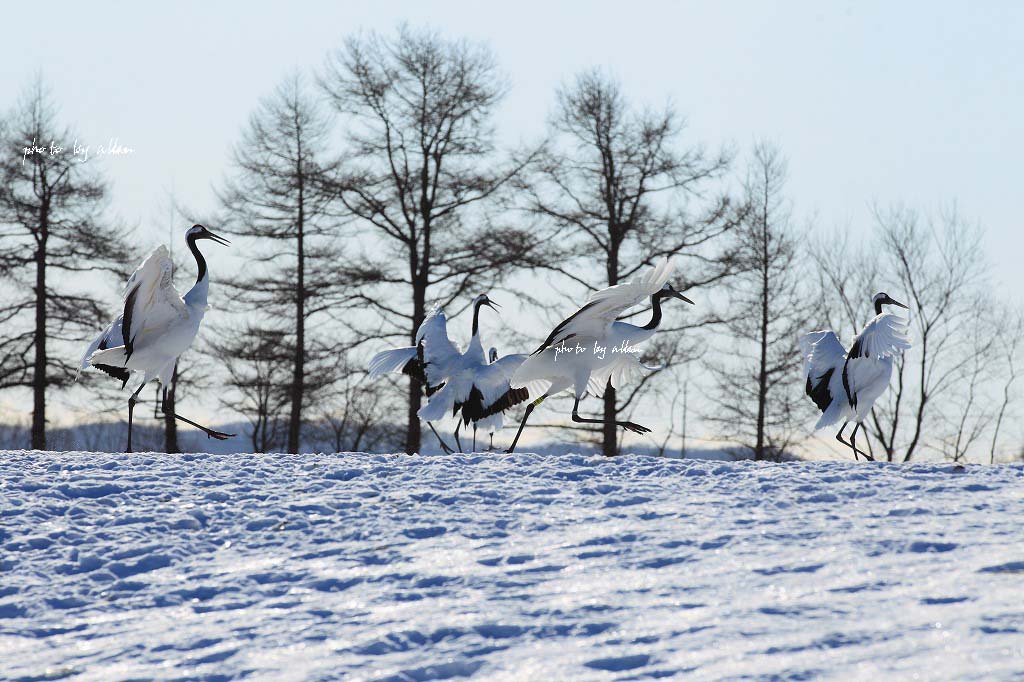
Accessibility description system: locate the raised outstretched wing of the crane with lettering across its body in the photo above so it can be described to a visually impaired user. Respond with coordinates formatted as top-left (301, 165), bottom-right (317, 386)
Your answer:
top-left (534, 253), bottom-right (675, 353)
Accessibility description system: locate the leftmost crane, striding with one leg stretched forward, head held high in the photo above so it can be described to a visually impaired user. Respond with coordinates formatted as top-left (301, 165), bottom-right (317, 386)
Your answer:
top-left (79, 225), bottom-right (234, 453)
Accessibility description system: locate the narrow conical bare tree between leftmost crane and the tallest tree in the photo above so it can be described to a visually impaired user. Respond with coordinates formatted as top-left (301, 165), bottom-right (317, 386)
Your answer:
top-left (220, 74), bottom-right (345, 453)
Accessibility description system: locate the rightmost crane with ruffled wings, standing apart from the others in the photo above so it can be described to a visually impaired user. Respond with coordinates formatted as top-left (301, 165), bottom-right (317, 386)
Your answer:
top-left (800, 292), bottom-right (910, 460)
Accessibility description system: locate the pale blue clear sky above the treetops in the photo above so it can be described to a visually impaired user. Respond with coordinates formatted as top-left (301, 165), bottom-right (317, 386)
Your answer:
top-left (0, 0), bottom-right (1024, 446)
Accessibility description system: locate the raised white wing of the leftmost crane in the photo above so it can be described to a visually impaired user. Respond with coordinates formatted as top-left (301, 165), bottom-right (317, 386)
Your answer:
top-left (119, 245), bottom-right (188, 357)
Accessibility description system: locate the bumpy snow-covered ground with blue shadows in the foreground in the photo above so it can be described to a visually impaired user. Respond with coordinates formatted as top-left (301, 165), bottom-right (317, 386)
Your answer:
top-left (0, 452), bottom-right (1024, 680)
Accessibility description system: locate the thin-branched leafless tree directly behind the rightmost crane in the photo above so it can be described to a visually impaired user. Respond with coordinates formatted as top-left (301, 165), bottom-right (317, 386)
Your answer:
top-left (815, 207), bottom-right (988, 462)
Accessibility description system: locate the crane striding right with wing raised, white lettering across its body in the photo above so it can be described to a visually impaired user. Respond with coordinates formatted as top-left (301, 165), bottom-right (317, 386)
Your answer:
top-left (508, 258), bottom-right (693, 453)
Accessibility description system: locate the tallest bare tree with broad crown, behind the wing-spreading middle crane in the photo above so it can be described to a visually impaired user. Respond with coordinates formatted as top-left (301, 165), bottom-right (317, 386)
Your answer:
top-left (321, 26), bottom-right (532, 453)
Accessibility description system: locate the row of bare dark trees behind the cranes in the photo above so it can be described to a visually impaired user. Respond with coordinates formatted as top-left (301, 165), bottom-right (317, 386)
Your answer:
top-left (0, 26), bottom-right (1024, 461)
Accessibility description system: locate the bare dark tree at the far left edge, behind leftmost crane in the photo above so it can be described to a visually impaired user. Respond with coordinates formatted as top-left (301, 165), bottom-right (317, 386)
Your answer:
top-left (0, 78), bottom-right (125, 450)
